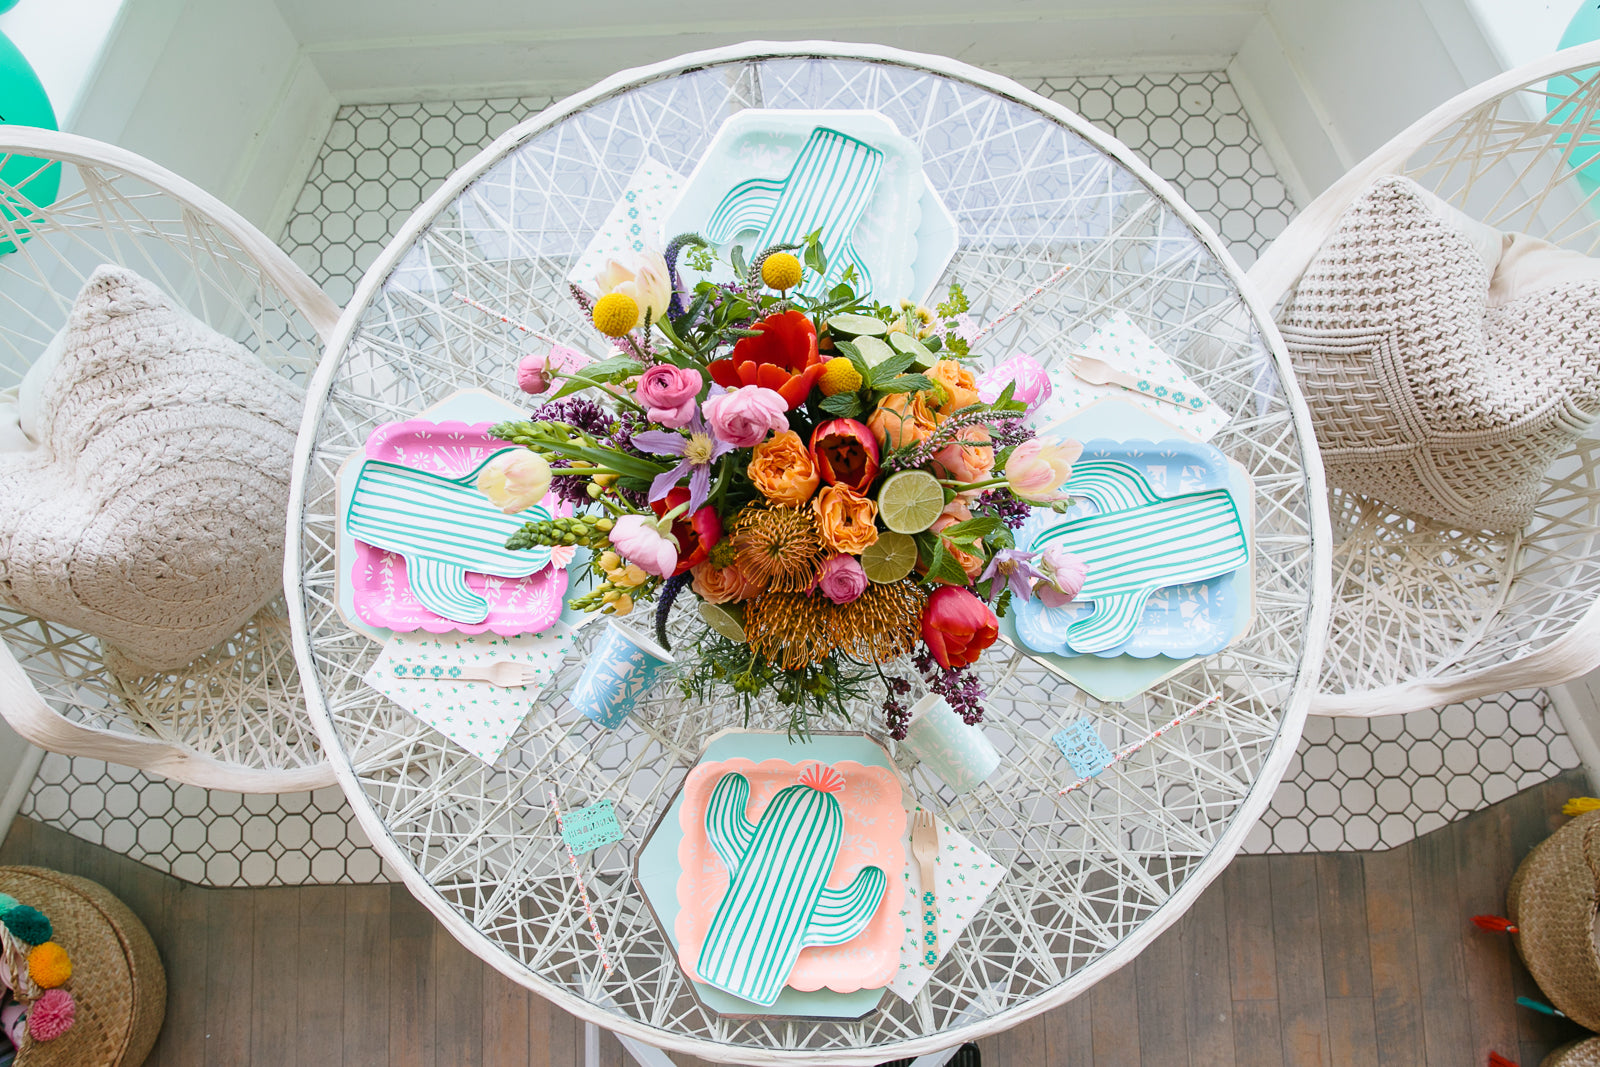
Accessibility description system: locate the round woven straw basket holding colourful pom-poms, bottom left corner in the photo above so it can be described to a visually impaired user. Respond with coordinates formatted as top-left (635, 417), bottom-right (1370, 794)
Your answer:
top-left (0, 867), bottom-right (166, 1067)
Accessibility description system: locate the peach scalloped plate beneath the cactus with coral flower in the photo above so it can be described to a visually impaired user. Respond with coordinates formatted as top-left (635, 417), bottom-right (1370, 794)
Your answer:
top-left (675, 758), bottom-right (906, 993)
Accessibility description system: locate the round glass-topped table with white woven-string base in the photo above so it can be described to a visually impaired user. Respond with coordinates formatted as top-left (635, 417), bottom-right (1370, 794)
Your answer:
top-left (286, 43), bottom-right (1330, 1064)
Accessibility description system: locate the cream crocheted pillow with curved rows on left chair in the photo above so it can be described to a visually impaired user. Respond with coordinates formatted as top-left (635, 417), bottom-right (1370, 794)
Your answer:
top-left (0, 267), bottom-right (302, 673)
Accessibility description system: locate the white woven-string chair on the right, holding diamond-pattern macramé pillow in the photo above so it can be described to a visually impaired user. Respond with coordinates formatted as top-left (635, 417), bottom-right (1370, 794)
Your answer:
top-left (1250, 43), bottom-right (1600, 715)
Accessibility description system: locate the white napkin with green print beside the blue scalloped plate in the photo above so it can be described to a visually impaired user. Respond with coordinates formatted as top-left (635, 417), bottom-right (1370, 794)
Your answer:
top-left (1032, 314), bottom-right (1232, 442)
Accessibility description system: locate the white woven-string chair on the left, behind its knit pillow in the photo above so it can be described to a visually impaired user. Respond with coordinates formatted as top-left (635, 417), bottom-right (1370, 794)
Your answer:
top-left (0, 126), bottom-right (339, 792)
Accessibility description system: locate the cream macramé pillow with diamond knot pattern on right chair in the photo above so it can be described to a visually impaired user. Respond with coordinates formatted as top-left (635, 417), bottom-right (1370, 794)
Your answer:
top-left (1278, 178), bottom-right (1600, 531)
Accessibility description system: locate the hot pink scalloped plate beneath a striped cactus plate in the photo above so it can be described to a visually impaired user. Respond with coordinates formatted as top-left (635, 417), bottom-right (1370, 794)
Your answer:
top-left (349, 419), bottom-right (573, 637)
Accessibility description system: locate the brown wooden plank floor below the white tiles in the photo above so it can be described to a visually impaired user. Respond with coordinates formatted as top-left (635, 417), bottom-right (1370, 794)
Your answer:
top-left (0, 771), bottom-right (1587, 1067)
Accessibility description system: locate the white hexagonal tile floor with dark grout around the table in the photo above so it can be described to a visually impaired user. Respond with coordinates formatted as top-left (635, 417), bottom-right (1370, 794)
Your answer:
top-left (12, 72), bottom-right (1578, 886)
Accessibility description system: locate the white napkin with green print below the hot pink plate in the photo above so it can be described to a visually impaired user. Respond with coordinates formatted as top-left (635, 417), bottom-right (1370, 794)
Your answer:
top-left (362, 622), bottom-right (573, 766)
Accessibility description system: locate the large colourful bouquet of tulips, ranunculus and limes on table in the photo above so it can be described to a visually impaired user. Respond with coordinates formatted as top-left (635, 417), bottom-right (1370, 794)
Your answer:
top-left (478, 235), bottom-right (1085, 737)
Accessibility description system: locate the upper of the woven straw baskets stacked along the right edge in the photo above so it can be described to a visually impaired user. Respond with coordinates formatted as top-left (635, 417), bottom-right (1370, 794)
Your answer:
top-left (1506, 811), bottom-right (1600, 1030)
